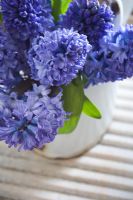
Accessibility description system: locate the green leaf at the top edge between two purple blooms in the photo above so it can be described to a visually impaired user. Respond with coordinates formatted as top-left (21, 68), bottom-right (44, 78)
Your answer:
top-left (52, 0), bottom-right (72, 21)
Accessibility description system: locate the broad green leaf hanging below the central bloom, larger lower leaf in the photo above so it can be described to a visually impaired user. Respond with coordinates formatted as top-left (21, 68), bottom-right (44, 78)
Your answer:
top-left (58, 77), bottom-right (84, 134)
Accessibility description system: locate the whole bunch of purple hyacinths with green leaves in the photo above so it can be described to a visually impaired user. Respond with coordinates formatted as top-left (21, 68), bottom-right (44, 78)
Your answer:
top-left (0, 0), bottom-right (133, 150)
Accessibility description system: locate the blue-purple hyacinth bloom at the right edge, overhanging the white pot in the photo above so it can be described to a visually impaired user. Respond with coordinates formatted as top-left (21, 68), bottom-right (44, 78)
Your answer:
top-left (84, 25), bottom-right (133, 85)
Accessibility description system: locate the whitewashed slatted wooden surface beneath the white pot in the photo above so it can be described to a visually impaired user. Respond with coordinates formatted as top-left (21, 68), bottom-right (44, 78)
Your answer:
top-left (0, 80), bottom-right (133, 200)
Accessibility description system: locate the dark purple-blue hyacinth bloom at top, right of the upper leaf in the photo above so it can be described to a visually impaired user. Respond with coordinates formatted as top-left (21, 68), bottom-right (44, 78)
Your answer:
top-left (59, 0), bottom-right (114, 48)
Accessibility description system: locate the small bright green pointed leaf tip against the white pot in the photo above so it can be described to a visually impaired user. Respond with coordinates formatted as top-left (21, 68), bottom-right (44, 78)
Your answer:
top-left (82, 96), bottom-right (102, 119)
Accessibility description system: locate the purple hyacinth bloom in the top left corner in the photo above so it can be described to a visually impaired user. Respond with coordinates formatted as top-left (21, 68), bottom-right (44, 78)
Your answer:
top-left (1, 0), bottom-right (54, 40)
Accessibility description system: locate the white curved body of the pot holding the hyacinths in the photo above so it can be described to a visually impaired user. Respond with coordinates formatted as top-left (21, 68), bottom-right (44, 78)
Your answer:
top-left (42, 83), bottom-right (116, 158)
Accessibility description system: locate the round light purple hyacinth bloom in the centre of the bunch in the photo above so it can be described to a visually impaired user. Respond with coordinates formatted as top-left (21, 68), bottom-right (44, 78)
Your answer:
top-left (28, 29), bottom-right (91, 86)
